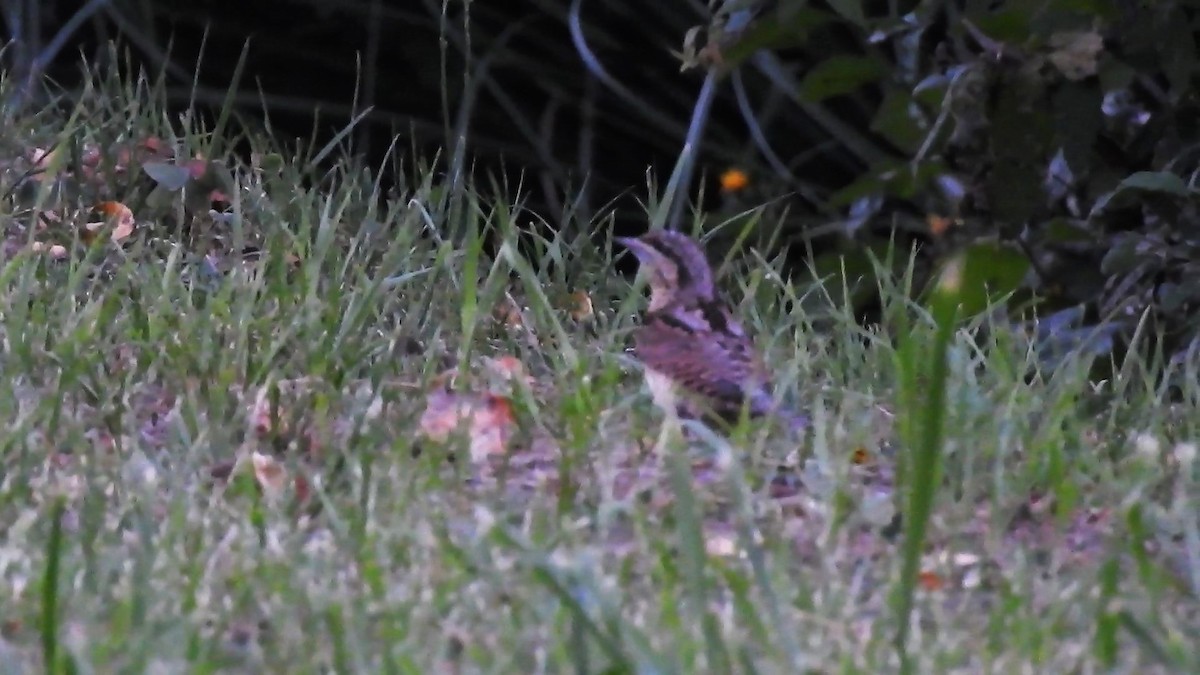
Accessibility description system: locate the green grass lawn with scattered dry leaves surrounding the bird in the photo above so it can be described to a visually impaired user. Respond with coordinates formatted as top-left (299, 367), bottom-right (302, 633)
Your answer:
top-left (0, 64), bottom-right (1200, 673)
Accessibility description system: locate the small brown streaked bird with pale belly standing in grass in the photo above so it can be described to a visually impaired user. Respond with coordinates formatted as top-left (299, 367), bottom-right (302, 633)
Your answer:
top-left (616, 229), bottom-right (808, 431)
